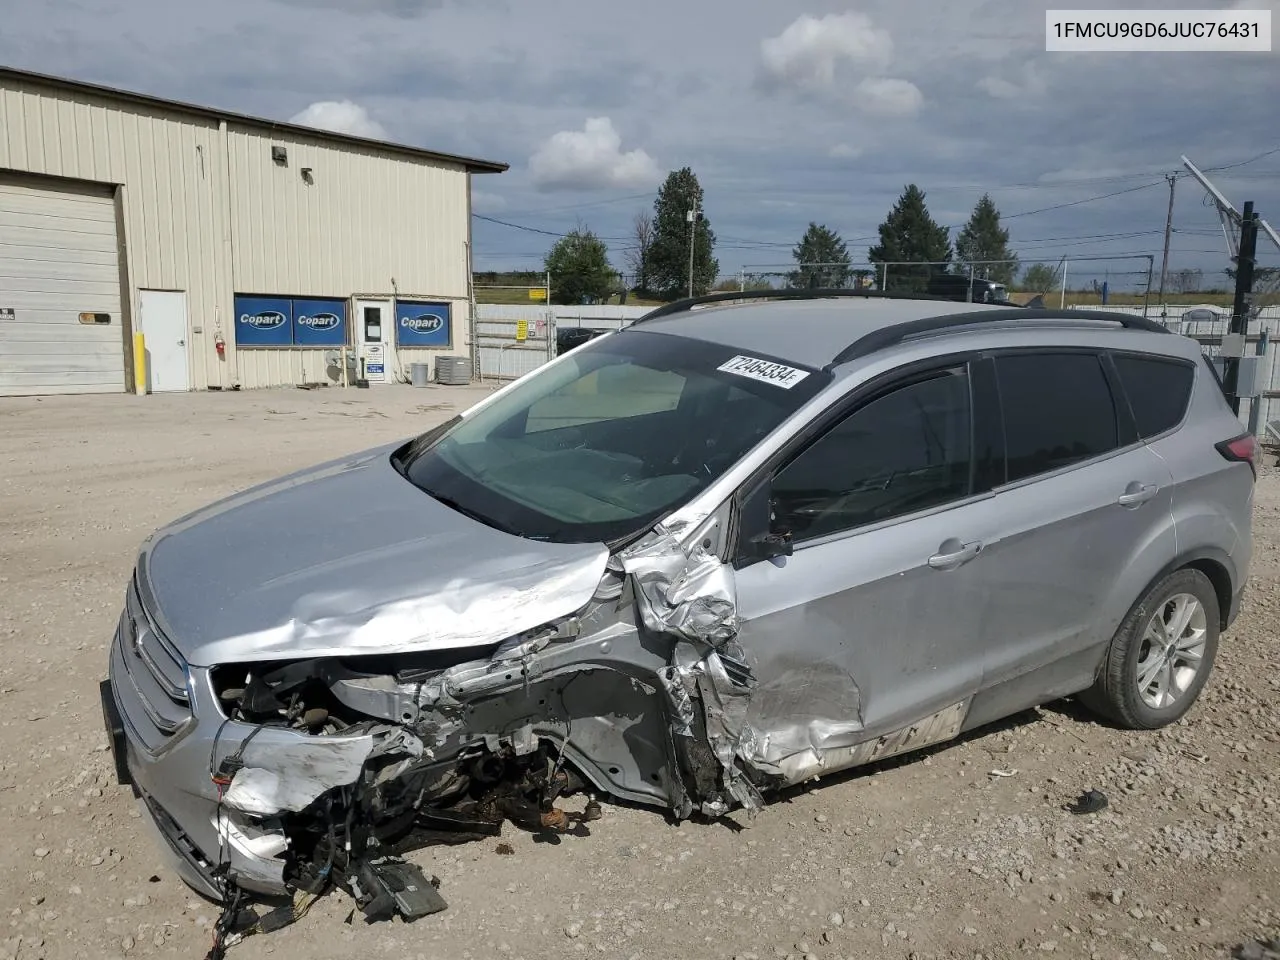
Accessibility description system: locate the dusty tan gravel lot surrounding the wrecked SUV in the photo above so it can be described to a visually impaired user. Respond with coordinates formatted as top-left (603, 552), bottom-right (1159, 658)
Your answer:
top-left (0, 387), bottom-right (1280, 960)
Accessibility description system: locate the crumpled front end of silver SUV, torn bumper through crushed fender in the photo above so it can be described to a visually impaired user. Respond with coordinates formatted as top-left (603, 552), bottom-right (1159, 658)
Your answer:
top-left (102, 508), bottom-right (829, 931)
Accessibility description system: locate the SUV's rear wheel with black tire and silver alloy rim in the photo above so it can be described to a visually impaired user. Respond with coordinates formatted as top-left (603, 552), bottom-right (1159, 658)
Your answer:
top-left (1080, 567), bottom-right (1222, 730)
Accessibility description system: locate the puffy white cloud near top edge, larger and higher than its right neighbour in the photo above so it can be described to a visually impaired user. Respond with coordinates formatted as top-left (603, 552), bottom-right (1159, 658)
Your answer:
top-left (760, 13), bottom-right (893, 93)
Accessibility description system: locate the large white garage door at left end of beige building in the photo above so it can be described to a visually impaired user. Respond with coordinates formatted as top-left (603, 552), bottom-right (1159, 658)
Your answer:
top-left (0, 179), bottom-right (125, 396)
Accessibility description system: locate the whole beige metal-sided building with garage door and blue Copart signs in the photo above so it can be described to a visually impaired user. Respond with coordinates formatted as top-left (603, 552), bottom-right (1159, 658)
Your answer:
top-left (0, 68), bottom-right (507, 394)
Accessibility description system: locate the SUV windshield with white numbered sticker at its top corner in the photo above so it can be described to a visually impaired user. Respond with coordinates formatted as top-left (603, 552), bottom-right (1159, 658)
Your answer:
top-left (396, 330), bottom-right (829, 543)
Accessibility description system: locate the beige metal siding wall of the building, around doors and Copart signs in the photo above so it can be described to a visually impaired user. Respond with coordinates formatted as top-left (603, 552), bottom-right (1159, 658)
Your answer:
top-left (0, 81), bottom-right (470, 389)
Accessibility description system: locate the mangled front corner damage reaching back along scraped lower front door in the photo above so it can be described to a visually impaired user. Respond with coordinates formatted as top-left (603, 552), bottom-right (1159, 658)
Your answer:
top-left (186, 496), bottom-right (968, 960)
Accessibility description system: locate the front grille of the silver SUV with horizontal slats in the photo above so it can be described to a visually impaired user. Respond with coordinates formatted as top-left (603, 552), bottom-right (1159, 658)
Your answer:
top-left (111, 582), bottom-right (192, 753)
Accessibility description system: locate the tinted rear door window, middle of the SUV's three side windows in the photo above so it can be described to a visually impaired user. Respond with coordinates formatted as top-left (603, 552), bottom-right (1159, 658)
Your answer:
top-left (996, 353), bottom-right (1120, 483)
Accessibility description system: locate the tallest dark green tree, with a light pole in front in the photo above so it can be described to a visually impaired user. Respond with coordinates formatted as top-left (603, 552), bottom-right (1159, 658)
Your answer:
top-left (645, 166), bottom-right (719, 300)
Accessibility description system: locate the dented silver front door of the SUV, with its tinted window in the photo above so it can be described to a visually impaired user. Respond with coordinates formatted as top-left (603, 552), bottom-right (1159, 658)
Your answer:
top-left (737, 365), bottom-right (993, 782)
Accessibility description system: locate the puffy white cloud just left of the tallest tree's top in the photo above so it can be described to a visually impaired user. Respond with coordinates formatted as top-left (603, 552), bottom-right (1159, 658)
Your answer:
top-left (529, 116), bottom-right (662, 191)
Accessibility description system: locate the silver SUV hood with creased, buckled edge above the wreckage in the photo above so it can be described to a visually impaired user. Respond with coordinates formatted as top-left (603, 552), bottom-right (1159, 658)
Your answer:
top-left (138, 444), bottom-right (609, 667)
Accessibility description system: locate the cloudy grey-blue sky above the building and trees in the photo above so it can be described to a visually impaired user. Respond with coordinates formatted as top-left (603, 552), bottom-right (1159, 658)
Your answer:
top-left (0, 0), bottom-right (1280, 289)
